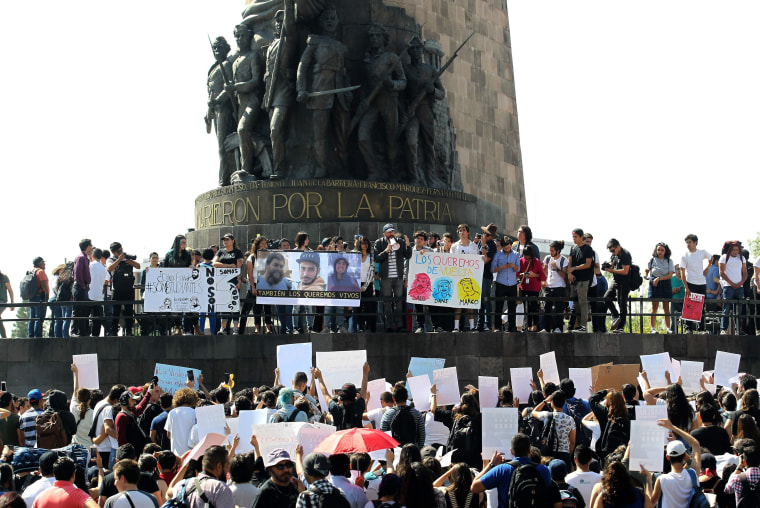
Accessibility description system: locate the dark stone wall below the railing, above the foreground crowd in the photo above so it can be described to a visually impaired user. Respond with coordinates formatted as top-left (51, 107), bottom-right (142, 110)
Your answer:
top-left (0, 333), bottom-right (760, 394)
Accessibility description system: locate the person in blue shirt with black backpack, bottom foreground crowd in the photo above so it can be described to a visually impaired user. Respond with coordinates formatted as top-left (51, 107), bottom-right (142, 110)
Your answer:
top-left (470, 434), bottom-right (562, 508)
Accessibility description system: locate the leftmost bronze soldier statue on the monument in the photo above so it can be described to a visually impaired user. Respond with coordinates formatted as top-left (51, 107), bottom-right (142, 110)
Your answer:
top-left (205, 37), bottom-right (237, 187)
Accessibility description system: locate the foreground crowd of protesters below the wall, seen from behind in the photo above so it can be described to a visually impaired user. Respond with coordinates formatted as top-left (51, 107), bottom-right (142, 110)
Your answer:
top-left (0, 358), bottom-right (760, 508)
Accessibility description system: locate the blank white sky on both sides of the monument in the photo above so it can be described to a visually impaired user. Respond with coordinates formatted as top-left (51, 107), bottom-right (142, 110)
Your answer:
top-left (0, 0), bottom-right (760, 310)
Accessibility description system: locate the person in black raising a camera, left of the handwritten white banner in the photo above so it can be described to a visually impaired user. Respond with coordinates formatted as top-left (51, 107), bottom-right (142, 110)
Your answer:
top-left (106, 242), bottom-right (140, 337)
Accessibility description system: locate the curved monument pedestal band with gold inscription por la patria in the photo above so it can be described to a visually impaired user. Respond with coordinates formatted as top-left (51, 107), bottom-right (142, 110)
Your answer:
top-left (187, 179), bottom-right (504, 249)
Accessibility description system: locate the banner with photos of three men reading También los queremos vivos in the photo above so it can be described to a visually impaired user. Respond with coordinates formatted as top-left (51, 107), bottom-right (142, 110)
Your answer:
top-left (254, 250), bottom-right (362, 307)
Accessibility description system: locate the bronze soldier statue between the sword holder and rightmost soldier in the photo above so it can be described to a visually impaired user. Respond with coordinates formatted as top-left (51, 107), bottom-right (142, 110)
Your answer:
top-left (359, 23), bottom-right (406, 181)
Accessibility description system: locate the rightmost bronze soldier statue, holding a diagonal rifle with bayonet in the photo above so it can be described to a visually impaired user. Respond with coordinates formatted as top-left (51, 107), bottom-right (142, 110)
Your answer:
top-left (404, 35), bottom-right (446, 189)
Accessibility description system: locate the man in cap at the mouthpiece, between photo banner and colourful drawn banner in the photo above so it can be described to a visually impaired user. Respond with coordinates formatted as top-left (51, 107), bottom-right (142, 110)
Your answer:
top-left (375, 223), bottom-right (412, 333)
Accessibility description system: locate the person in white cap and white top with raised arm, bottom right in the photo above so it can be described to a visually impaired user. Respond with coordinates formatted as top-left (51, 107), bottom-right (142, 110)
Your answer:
top-left (641, 419), bottom-right (702, 508)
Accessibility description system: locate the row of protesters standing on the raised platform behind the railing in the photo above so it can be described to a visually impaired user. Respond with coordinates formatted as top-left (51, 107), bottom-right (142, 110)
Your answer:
top-left (0, 224), bottom-right (760, 337)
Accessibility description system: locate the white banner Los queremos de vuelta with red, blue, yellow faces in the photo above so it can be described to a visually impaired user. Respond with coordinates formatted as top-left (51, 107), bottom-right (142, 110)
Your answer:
top-left (407, 251), bottom-right (485, 309)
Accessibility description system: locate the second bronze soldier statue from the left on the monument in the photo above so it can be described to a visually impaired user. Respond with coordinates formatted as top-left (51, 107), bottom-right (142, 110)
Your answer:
top-left (225, 25), bottom-right (272, 178)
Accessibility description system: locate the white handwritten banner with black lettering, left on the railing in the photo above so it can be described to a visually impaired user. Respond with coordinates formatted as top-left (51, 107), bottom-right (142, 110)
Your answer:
top-left (143, 267), bottom-right (240, 313)
